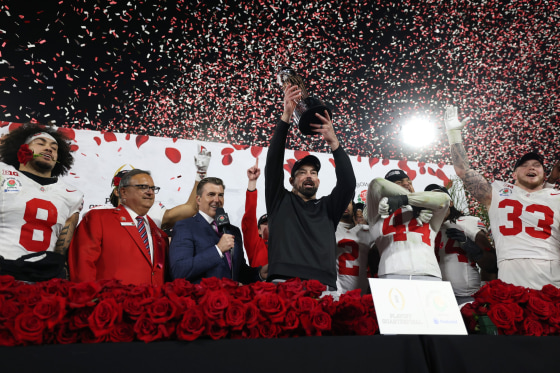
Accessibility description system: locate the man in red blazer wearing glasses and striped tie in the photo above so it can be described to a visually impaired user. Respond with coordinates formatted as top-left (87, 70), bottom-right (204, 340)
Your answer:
top-left (68, 169), bottom-right (169, 285)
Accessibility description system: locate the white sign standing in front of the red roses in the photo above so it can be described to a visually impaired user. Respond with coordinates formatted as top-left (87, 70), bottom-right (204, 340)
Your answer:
top-left (369, 278), bottom-right (467, 335)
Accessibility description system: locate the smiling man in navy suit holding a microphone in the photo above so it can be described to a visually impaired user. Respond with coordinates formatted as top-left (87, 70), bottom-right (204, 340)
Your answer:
top-left (169, 177), bottom-right (267, 284)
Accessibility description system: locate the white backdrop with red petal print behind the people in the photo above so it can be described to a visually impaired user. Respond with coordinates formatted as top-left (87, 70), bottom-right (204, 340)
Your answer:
top-left (0, 122), bottom-right (455, 226)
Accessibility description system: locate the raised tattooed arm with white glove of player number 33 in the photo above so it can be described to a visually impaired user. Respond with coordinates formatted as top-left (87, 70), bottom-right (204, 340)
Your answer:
top-left (444, 106), bottom-right (492, 208)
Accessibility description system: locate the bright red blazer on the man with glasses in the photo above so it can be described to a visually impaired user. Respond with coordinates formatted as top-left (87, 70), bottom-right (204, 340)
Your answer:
top-left (68, 205), bottom-right (169, 285)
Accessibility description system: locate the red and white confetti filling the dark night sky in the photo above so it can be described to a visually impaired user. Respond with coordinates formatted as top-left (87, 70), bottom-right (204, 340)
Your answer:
top-left (0, 0), bottom-right (560, 179)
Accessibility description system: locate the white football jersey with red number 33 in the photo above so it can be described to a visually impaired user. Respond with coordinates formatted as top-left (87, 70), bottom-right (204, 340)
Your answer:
top-left (488, 181), bottom-right (560, 263)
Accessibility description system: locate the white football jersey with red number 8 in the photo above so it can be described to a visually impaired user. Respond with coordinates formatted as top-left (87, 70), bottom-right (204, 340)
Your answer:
top-left (0, 162), bottom-right (84, 260)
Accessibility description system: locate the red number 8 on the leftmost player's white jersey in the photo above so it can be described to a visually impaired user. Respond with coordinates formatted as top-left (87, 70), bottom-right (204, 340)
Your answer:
top-left (19, 198), bottom-right (58, 252)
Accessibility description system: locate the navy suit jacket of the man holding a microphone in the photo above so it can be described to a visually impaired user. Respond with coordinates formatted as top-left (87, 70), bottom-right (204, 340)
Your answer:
top-left (169, 213), bottom-right (260, 284)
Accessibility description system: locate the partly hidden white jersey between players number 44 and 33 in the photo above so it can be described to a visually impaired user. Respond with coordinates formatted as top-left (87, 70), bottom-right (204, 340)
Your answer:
top-left (435, 216), bottom-right (486, 297)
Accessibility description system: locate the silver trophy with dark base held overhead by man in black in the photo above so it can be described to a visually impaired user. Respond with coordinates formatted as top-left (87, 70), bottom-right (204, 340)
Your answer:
top-left (276, 67), bottom-right (332, 136)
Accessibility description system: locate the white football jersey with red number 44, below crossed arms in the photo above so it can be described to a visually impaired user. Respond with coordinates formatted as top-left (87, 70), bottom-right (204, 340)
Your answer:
top-left (370, 205), bottom-right (441, 278)
